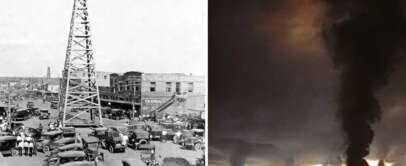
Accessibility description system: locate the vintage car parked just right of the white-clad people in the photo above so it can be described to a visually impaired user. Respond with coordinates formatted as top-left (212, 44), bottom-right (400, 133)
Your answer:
top-left (37, 132), bottom-right (76, 153)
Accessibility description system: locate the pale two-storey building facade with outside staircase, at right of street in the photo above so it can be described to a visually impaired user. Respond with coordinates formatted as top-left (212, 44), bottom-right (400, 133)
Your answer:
top-left (141, 73), bottom-right (206, 113)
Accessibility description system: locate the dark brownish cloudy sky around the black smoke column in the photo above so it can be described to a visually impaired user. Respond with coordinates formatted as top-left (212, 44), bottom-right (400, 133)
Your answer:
top-left (209, 0), bottom-right (406, 166)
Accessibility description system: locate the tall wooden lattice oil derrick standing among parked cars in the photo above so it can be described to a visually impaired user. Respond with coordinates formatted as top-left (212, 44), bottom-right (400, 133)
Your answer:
top-left (59, 0), bottom-right (102, 126)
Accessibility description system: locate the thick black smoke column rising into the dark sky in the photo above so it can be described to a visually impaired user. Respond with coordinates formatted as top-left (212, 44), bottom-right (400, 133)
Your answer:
top-left (322, 0), bottom-right (406, 166)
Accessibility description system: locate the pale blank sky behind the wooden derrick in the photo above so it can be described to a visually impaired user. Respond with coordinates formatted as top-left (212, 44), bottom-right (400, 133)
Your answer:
top-left (0, 0), bottom-right (207, 76)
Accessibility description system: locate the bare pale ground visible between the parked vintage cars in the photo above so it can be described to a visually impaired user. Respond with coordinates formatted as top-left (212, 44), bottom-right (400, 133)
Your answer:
top-left (0, 100), bottom-right (204, 166)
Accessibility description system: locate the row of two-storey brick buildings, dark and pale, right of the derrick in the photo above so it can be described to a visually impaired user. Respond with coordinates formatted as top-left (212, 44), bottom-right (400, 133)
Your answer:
top-left (99, 71), bottom-right (205, 116)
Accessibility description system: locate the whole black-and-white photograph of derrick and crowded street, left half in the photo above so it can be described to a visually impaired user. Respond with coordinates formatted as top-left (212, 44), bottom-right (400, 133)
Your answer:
top-left (0, 0), bottom-right (208, 166)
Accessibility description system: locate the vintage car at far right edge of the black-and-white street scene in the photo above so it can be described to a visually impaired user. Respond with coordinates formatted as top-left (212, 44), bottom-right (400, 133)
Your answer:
top-left (179, 130), bottom-right (205, 150)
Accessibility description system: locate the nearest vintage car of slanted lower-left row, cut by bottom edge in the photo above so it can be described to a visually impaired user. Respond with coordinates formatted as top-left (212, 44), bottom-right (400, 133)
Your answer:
top-left (44, 151), bottom-right (97, 166)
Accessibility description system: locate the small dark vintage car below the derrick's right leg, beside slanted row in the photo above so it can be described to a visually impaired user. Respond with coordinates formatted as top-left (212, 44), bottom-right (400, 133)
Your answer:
top-left (82, 137), bottom-right (104, 161)
